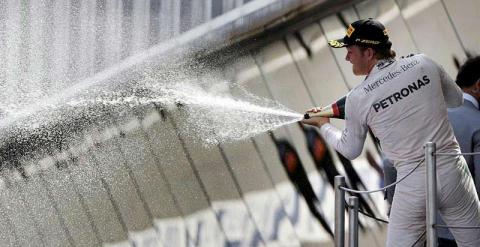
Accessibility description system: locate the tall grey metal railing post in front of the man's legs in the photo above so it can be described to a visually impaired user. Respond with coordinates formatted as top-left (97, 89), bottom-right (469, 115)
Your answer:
top-left (425, 142), bottom-right (437, 247)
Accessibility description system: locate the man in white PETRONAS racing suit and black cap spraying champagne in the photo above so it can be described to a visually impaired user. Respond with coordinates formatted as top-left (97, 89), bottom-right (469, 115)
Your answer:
top-left (302, 19), bottom-right (480, 247)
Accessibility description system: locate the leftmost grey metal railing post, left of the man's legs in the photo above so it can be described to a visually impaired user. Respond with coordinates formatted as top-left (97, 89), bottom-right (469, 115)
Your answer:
top-left (334, 175), bottom-right (345, 247)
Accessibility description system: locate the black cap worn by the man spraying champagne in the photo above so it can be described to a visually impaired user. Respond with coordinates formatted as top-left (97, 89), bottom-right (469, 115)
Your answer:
top-left (328, 18), bottom-right (392, 49)
